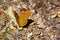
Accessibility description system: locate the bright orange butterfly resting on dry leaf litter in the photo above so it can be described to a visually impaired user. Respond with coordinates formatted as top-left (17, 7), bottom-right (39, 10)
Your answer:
top-left (16, 11), bottom-right (31, 27)
